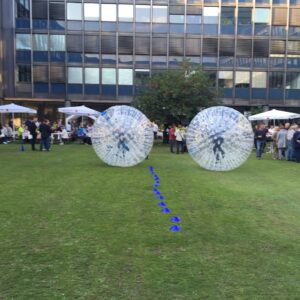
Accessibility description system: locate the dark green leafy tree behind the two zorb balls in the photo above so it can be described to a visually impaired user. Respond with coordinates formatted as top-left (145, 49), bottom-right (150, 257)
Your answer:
top-left (132, 61), bottom-right (217, 122)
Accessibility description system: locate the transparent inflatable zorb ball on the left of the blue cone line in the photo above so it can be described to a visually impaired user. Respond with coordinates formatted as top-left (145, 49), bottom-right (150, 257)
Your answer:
top-left (92, 105), bottom-right (153, 167)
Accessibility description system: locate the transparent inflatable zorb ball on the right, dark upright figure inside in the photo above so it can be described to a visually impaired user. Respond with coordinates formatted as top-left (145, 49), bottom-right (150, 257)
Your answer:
top-left (186, 106), bottom-right (253, 171)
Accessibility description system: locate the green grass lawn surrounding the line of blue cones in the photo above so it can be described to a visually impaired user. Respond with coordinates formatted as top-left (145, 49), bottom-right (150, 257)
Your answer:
top-left (0, 144), bottom-right (300, 300)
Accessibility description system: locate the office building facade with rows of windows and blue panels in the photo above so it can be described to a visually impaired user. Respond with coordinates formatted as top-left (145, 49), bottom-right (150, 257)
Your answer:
top-left (0, 0), bottom-right (300, 116)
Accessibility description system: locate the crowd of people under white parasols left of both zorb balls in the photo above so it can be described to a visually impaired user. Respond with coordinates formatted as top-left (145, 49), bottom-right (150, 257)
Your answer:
top-left (0, 117), bottom-right (93, 151)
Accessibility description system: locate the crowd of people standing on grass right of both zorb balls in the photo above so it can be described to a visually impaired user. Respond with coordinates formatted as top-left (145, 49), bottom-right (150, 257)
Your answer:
top-left (254, 123), bottom-right (300, 163)
